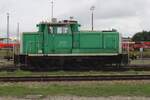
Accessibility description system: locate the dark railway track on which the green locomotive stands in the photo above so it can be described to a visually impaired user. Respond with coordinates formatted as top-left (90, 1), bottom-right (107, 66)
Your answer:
top-left (0, 65), bottom-right (150, 72)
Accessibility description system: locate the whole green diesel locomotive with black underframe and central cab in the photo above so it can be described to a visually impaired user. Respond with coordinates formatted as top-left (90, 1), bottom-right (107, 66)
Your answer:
top-left (14, 20), bottom-right (128, 70)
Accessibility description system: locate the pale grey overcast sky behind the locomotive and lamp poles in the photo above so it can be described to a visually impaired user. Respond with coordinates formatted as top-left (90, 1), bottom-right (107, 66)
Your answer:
top-left (0, 0), bottom-right (150, 36)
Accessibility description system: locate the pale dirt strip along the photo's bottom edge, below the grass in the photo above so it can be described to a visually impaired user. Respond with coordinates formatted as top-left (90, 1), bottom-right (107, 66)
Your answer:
top-left (0, 96), bottom-right (150, 100)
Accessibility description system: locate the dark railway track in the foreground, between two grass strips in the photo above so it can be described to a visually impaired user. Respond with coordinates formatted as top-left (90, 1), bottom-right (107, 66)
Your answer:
top-left (0, 75), bottom-right (150, 82)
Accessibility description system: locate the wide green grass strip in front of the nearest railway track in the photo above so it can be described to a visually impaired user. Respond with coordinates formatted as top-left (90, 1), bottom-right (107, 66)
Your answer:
top-left (0, 83), bottom-right (150, 97)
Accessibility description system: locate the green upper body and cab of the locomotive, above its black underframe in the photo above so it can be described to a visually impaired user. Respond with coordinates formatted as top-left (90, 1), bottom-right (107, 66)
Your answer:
top-left (22, 22), bottom-right (120, 54)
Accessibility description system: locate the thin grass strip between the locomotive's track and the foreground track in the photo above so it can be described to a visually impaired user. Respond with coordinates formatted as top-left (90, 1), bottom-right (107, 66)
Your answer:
top-left (0, 70), bottom-right (150, 77)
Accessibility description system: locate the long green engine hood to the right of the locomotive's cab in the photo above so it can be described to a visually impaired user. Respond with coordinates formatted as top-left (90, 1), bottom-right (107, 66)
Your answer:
top-left (72, 32), bottom-right (119, 53)
